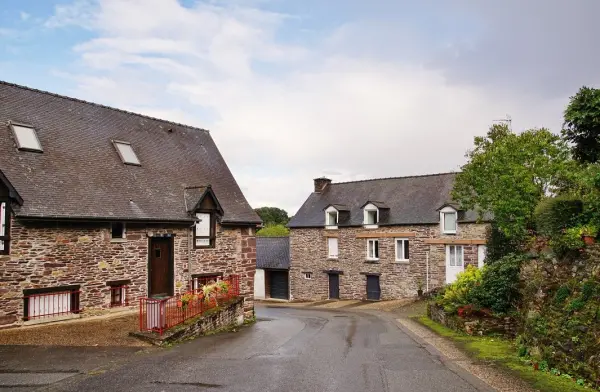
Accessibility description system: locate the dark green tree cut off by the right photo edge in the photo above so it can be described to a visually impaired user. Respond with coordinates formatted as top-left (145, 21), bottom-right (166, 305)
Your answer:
top-left (562, 86), bottom-right (600, 163)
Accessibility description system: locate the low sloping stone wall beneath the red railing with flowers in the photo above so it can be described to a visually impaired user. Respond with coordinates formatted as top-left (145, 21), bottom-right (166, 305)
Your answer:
top-left (131, 297), bottom-right (244, 346)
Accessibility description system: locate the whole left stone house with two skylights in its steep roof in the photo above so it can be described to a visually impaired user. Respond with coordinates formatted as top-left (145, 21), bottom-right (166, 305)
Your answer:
top-left (0, 82), bottom-right (261, 325)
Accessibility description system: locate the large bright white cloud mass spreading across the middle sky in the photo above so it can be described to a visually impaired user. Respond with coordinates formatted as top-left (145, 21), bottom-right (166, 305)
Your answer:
top-left (46, 0), bottom-right (580, 214)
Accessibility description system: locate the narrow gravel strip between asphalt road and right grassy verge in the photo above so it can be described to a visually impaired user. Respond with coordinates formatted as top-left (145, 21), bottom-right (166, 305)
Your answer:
top-left (397, 317), bottom-right (539, 392)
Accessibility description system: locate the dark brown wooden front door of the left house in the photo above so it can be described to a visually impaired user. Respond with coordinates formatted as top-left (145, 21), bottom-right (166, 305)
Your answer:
top-left (148, 238), bottom-right (173, 297)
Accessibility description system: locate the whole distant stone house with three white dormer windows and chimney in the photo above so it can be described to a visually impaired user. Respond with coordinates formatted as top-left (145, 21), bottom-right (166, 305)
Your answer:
top-left (288, 173), bottom-right (488, 300)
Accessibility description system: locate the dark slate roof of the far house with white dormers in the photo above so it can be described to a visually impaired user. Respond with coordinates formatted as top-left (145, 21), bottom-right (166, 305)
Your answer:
top-left (288, 173), bottom-right (477, 228)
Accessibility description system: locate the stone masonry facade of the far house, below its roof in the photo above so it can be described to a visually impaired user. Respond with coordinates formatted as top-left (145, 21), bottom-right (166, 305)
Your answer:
top-left (290, 223), bottom-right (487, 300)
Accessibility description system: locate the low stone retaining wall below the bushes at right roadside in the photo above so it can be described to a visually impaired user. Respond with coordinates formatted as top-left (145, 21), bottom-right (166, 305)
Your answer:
top-left (427, 303), bottom-right (518, 337)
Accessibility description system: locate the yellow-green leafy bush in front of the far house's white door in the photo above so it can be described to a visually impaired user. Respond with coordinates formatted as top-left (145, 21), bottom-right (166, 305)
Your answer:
top-left (437, 265), bottom-right (481, 314)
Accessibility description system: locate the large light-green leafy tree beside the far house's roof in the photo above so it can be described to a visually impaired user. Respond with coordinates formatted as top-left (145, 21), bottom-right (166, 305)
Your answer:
top-left (452, 125), bottom-right (574, 239)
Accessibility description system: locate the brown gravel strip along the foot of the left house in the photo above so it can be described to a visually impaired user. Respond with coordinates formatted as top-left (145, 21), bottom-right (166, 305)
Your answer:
top-left (0, 314), bottom-right (149, 347)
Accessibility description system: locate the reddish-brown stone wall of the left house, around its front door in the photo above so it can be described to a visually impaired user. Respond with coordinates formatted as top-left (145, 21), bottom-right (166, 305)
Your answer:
top-left (0, 219), bottom-right (256, 325)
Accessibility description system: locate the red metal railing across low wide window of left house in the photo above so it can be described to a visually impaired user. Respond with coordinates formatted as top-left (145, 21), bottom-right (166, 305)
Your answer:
top-left (23, 291), bottom-right (81, 321)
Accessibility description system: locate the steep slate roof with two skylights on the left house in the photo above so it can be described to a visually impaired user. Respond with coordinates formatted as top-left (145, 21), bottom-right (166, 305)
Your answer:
top-left (0, 81), bottom-right (261, 223)
